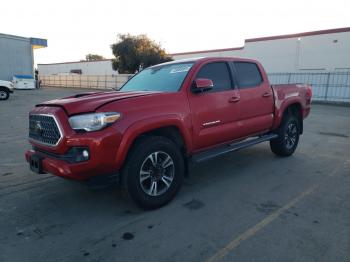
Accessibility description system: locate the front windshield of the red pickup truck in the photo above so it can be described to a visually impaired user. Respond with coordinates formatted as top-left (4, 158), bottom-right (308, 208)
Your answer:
top-left (121, 62), bottom-right (194, 92)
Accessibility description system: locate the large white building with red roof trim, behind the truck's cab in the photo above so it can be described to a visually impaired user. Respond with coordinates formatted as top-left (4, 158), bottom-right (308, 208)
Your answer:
top-left (172, 27), bottom-right (350, 73)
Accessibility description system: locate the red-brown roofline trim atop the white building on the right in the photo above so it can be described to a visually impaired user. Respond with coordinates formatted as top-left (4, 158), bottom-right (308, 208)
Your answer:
top-left (170, 27), bottom-right (350, 56)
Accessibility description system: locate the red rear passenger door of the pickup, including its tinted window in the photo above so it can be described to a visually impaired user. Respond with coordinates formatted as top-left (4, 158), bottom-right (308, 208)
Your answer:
top-left (233, 61), bottom-right (274, 136)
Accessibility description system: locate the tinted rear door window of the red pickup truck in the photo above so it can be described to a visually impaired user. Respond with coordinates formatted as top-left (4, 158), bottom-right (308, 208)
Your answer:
top-left (234, 62), bottom-right (263, 88)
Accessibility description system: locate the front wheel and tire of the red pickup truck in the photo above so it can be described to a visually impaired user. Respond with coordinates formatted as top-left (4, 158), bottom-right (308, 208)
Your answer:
top-left (122, 136), bottom-right (185, 209)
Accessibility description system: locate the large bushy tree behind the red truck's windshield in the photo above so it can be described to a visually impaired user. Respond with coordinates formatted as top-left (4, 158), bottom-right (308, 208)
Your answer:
top-left (111, 34), bottom-right (173, 74)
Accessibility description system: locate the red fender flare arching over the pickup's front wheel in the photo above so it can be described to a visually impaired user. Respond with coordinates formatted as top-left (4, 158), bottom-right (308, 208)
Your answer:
top-left (116, 114), bottom-right (192, 169)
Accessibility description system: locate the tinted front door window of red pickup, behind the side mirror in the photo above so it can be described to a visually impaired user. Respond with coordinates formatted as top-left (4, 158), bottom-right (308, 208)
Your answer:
top-left (196, 62), bottom-right (232, 92)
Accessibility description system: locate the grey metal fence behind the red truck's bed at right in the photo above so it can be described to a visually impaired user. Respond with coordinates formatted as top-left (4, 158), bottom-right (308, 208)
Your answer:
top-left (268, 72), bottom-right (350, 102)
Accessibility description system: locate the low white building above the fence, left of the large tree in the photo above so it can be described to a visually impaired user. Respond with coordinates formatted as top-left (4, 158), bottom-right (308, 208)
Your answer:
top-left (38, 59), bottom-right (118, 75)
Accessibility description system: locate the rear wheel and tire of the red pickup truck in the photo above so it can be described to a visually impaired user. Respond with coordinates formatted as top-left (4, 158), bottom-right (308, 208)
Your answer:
top-left (270, 114), bottom-right (300, 157)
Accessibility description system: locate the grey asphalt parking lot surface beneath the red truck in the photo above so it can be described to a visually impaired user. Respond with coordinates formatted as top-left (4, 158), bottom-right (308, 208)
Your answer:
top-left (0, 88), bottom-right (350, 262)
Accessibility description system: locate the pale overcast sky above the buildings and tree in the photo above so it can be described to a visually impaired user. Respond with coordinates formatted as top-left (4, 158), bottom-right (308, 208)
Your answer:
top-left (0, 0), bottom-right (350, 63)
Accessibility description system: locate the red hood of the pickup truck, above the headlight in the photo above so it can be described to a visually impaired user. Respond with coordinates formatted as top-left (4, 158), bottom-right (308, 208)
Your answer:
top-left (36, 91), bottom-right (160, 115)
